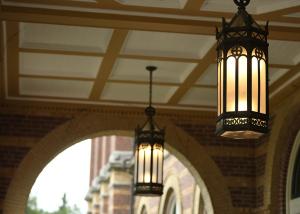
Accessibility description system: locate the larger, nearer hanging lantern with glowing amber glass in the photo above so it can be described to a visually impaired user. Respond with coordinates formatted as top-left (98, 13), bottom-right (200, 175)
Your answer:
top-left (216, 0), bottom-right (269, 139)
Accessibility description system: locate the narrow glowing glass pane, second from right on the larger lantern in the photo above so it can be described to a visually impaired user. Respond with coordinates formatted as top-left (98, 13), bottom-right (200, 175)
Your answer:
top-left (252, 57), bottom-right (258, 112)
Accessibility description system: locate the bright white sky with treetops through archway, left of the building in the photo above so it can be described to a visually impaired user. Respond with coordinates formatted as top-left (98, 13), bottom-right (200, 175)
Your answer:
top-left (25, 139), bottom-right (91, 214)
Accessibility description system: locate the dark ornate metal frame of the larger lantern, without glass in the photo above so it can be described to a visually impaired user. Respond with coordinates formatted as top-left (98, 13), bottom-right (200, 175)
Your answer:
top-left (216, 0), bottom-right (269, 139)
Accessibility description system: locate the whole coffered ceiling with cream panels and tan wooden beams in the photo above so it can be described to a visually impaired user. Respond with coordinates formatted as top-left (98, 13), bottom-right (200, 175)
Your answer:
top-left (0, 0), bottom-right (300, 111)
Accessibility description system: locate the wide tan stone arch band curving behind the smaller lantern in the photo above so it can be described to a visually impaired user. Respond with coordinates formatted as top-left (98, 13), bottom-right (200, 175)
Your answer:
top-left (3, 113), bottom-right (233, 214)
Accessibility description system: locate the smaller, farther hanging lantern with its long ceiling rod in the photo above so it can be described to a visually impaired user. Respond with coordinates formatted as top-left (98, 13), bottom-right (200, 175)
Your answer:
top-left (134, 66), bottom-right (165, 196)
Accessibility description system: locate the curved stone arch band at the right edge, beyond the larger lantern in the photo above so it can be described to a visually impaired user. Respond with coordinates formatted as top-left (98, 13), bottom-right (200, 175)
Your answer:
top-left (265, 95), bottom-right (300, 214)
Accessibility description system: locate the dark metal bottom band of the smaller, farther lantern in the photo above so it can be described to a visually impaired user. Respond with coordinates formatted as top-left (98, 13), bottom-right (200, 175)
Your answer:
top-left (134, 183), bottom-right (163, 197)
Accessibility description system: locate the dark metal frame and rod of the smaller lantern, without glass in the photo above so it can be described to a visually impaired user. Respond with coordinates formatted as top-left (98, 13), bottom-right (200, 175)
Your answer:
top-left (133, 66), bottom-right (165, 196)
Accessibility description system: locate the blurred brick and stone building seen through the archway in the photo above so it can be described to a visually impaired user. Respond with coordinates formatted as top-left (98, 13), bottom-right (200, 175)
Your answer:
top-left (85, 136), bottom-right (213, 214)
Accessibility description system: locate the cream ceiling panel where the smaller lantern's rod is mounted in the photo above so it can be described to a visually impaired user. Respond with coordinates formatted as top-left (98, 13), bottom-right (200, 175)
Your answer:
top-left (110, 59), bottom-right (196, 83)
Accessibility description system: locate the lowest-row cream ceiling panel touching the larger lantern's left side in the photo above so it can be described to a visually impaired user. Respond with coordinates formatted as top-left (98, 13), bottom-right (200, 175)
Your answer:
top-left (179, 87), bottom-right (217, 106)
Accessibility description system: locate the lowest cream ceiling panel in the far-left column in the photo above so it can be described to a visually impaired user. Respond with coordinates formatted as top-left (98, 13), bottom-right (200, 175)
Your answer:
top-left (19, 78), bottom-right (93, 98)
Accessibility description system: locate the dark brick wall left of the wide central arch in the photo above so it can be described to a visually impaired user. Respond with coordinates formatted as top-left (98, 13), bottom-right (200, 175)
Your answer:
top-left (0, 112), bottom-right (69, 213)
